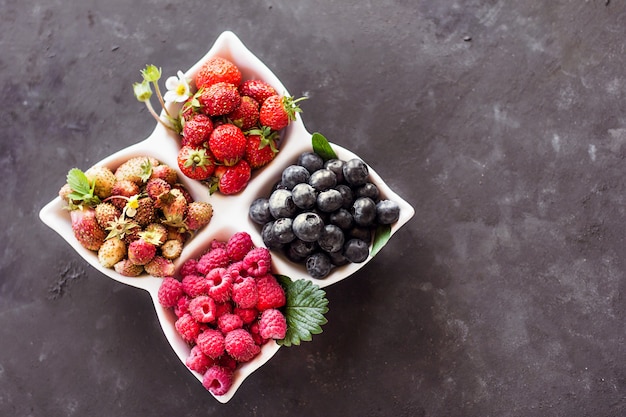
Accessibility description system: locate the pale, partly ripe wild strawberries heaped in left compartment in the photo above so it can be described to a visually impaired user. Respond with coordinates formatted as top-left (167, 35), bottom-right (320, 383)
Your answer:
top-left (59, 156), bottom-right (213, 277)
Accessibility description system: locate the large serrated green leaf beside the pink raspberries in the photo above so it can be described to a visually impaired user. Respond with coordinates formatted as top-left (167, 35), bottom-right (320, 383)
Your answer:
top-left (276, 275), bottom-right (328, 346)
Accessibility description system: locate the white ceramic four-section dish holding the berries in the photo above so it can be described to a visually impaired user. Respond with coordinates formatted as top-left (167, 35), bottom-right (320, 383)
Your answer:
top-left (39, 32), bottom-right (415, 403)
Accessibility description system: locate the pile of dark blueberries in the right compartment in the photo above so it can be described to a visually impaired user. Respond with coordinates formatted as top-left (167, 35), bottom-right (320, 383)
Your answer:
top-left (249, 152), bottom-right (400, 279)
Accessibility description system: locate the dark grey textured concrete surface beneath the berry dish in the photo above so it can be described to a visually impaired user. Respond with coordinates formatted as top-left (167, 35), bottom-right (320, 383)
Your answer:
top-left (0, 0), bottom-right (626, 417)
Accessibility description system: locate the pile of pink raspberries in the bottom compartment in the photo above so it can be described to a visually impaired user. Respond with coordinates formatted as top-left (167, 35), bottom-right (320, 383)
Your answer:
top-left (158, 232), bottom-right (287, 396)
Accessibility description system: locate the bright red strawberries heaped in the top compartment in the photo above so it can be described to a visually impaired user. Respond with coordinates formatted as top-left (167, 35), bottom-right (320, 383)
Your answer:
top-left (178, 57), bottom-right (300, 195)
